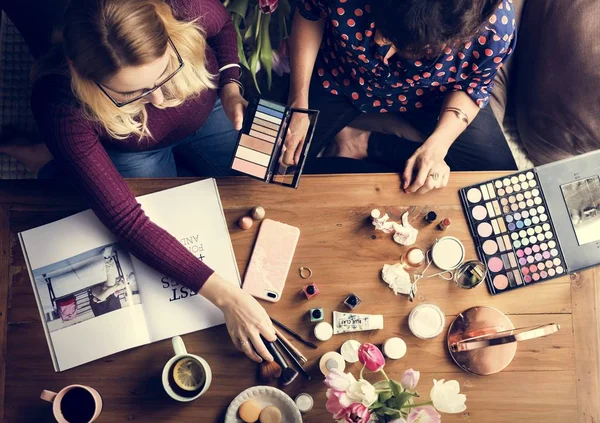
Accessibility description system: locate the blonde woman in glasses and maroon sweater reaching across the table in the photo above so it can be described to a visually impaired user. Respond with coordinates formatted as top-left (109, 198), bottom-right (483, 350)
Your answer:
top-left (22, 0), bottom-right (275, 361)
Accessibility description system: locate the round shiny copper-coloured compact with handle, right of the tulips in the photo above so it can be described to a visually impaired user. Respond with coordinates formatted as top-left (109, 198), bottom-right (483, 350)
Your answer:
top-left (447, 307), bottom-right (560, 376)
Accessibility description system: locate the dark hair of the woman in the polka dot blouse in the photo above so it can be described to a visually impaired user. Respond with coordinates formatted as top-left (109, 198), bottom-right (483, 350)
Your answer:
top-left (371, 0), bottom-right (502, 57)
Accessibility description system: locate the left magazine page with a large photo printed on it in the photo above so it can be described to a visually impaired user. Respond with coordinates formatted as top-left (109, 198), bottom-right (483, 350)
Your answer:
top-left (19, 214), bottom-right (150, 371)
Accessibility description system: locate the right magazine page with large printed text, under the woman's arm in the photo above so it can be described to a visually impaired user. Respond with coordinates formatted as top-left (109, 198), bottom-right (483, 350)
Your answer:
top-left (134, 179), bottom-right (241, 342)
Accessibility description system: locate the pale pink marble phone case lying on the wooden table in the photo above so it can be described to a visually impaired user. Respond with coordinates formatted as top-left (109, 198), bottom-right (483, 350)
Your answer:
top-left (242, 219), bottom-right (300, 303)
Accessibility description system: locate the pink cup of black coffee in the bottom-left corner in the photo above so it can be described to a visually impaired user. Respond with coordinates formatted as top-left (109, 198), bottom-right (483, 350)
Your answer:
top-left (40, 385), bottom-right (102, 423)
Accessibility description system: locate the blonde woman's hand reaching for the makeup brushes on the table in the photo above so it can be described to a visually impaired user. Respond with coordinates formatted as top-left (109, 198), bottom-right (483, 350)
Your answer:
top-left (200, 273), bottom-right (276, 363)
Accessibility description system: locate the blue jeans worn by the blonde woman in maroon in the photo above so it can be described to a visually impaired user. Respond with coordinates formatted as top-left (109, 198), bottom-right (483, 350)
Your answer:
top-left (38, 100), bottom-right (238, 179)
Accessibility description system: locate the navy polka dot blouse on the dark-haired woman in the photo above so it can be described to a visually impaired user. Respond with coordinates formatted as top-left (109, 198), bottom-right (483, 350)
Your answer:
top-left (298, 0), bottom-right (516, 113)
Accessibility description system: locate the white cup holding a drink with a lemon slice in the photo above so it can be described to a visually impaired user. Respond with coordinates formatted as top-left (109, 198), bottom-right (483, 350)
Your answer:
top-left (162, 336), bottom-right (212, 402)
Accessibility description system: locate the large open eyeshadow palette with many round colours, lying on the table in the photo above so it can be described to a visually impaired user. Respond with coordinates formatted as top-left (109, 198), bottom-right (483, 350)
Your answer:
top-left (459, 151), bottom-right (600, 295)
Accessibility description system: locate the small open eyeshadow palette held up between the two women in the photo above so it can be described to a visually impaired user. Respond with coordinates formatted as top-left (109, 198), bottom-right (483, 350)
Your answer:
top-left (231, 99), bottom-right (319, 188)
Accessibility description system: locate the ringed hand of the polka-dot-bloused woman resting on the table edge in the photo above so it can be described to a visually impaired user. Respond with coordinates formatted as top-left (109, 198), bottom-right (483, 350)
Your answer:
top-left (402, 139), bottom-right (450, 194)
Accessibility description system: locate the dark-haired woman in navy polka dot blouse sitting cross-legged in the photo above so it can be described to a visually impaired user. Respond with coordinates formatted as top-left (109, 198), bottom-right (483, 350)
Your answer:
top-left (284, 0), bottom-right (516, 193)
